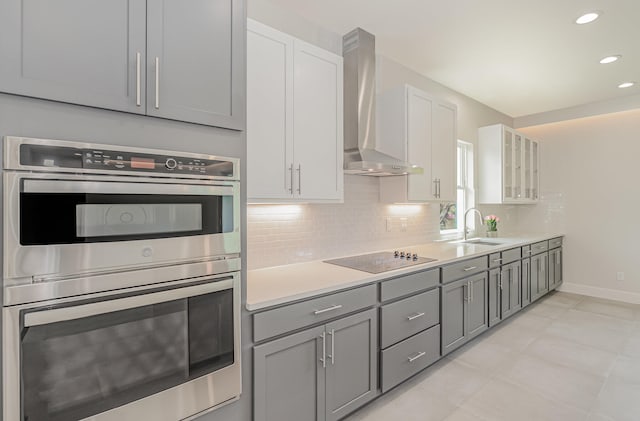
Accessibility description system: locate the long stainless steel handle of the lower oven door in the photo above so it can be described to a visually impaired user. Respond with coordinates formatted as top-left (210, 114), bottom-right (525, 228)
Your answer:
top-left (24, 277), bottom-right (234, 327)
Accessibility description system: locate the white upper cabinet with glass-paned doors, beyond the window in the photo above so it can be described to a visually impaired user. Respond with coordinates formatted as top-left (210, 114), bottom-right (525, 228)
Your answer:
top-left (478, 124), bottom-right (539, 204)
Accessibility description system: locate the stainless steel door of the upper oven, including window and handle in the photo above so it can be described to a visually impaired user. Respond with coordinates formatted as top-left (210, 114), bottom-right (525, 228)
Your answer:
top-left (4, 172), bottom-right (240, 279)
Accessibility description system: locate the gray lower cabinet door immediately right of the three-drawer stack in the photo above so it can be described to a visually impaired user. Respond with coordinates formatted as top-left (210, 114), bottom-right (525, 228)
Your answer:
top-left (440, 279), bottom-right (469, 355)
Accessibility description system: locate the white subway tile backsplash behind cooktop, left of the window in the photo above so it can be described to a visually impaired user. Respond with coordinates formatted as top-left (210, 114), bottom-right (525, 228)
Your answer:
top-left (247, 175), bottom-right (440, 269)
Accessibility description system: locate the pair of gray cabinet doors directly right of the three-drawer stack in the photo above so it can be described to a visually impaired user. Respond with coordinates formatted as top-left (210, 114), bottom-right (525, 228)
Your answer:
top-left (440, 272), bottom-right (489, 355)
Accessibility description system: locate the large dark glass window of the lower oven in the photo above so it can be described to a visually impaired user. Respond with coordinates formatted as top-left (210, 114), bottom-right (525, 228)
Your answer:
top-left (21, 289), bottom-right (234, 421)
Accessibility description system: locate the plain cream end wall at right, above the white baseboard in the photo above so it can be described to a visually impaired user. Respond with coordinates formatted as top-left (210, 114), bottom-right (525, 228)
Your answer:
top-left (519, 109), bottom-right (640, 303)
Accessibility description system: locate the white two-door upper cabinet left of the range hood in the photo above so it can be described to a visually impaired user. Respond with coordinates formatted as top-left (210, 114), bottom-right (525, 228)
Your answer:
top-left (247, 19), bottom-right (344, 203)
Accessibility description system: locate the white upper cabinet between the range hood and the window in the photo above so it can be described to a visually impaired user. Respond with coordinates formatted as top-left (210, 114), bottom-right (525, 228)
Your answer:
top-left (378, 85), bottom-right (457, 203)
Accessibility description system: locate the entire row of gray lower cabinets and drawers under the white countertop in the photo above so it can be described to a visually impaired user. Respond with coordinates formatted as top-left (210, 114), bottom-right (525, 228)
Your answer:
top-left (253, 237), bottom-right (563, 421)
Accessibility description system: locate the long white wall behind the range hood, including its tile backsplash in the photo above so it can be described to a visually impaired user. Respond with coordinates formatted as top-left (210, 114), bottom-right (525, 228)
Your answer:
top-left (247, 0), bottom-right (517, 269)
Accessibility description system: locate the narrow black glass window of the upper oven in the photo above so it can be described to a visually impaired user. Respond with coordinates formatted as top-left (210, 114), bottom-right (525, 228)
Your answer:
top-left (20, 192), bottom-right (233, 246)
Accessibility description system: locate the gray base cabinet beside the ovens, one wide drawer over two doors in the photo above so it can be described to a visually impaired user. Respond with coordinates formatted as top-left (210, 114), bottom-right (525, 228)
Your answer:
top-left (253, 285), bottom-right (378, 421)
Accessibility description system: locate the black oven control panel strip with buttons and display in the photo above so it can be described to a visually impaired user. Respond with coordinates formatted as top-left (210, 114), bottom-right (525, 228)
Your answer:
top-left (20, 144), bottom-right (233, 177)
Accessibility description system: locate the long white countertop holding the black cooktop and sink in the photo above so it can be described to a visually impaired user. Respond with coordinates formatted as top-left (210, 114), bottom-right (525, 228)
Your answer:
top-left (247, 233), bottom-right (563, 311)
